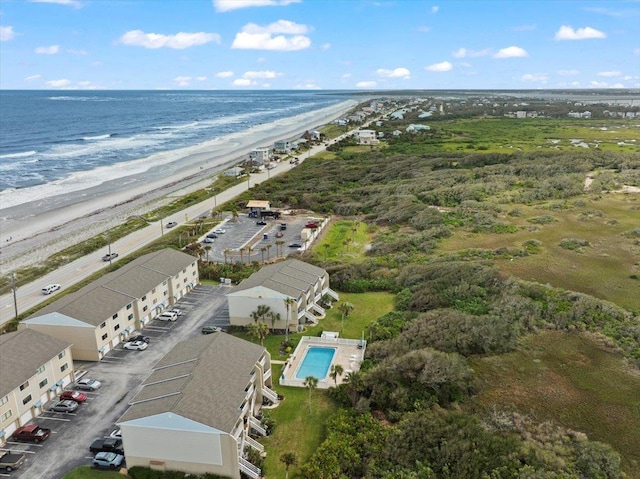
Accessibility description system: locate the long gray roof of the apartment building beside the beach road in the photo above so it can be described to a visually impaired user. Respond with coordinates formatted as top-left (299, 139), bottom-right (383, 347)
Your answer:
top-left (29, 249), bottom-right (197, 326)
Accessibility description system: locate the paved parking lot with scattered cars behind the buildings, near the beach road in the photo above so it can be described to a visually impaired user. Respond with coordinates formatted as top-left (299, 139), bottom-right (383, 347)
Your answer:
top-left (200, 214), bottom-right (317, 263)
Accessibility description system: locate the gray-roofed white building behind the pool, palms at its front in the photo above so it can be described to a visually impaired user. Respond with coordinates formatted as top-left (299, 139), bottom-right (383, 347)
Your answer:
top-left (227, 259), bottom-right (339, 331)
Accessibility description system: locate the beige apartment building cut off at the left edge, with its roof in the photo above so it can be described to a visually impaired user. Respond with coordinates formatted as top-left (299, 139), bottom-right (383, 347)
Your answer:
top-left (0, 329), bottom-right (74, 447)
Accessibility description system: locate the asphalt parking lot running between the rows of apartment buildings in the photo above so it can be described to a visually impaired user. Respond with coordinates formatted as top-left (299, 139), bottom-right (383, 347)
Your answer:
top-left (0, 285), bottom-right (229, 479)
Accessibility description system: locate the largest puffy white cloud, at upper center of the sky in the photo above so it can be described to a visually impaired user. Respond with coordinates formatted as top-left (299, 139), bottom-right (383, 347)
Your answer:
top-left (231, 20), bottom-right (311, 51)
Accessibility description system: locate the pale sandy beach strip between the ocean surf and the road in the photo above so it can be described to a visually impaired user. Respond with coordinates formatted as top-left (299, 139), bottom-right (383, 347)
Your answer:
top-left (0, 100), bottom-right (356, 274)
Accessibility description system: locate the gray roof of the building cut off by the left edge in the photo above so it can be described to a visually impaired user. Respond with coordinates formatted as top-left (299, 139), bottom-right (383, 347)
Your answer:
top-left (0, 329), bottom-right (71, 397)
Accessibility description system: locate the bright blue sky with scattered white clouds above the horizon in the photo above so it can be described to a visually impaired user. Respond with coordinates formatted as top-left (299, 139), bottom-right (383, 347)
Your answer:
top-left (0, 0), bottom-right (640, 90)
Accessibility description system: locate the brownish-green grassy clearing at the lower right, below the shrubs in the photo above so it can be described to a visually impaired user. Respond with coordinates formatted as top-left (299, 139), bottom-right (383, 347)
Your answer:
top-left (469, 332), bottom-right (640, 478)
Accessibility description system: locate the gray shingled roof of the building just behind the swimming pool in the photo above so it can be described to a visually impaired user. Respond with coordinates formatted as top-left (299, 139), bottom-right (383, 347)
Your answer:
top-left (230, 259), bottom-right (326, 299)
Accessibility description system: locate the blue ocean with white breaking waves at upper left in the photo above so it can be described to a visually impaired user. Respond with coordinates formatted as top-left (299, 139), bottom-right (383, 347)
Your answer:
top-left (0, 91), bottom-right (356, 209)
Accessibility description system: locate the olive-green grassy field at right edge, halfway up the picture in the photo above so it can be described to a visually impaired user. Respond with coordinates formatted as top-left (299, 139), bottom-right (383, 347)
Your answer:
top-left (438, 194), bottom-right (640, 311)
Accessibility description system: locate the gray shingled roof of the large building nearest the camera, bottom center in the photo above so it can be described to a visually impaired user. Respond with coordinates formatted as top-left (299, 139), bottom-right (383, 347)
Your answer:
top-left (118, 333), bottom-right (265, 433)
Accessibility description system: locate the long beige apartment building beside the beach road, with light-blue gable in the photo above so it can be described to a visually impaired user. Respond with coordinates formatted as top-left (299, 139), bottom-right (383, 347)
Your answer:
top-left (18, 249), bottom-right (200, 361)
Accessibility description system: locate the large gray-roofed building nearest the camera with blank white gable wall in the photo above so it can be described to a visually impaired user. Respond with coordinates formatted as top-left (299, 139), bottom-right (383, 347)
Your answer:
top-left (117, 333), bottom-right (278, 479)
